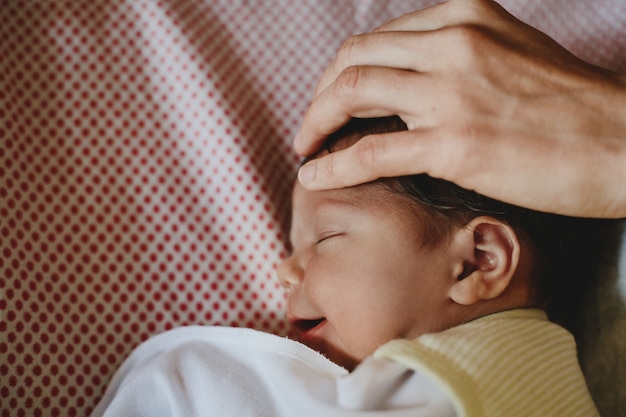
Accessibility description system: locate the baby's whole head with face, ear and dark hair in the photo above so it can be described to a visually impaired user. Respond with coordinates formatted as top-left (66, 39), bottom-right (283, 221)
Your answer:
top-left (278, 117), bottom-right (608, 369)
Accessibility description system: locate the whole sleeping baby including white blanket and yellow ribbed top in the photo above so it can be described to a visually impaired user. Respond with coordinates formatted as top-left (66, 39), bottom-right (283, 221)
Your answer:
top-left (93, 117), bottom-right (600, 417)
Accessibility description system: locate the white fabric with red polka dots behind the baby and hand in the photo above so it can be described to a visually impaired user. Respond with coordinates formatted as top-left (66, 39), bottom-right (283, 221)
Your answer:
top-left (0, 0), bottom-right (626, 417)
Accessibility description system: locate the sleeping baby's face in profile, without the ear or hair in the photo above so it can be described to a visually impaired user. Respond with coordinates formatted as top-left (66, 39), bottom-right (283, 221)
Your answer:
top-left (277, 180), bottom-right (455, 370)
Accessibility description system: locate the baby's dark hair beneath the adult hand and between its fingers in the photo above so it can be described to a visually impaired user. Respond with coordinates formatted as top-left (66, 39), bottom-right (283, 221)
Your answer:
top-left (314, 116), bottom-right (617, 332)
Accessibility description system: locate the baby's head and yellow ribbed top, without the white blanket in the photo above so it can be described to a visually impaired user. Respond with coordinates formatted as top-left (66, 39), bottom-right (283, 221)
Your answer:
top-left (277, 117), bottom-right (597, 416)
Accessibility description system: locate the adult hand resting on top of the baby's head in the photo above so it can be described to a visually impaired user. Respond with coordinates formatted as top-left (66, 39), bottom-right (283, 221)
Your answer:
top-left (294, 0), bottom-right (626, 217)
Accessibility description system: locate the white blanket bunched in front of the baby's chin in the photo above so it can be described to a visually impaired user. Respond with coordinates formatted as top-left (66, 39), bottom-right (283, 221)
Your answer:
top-left (92, 326), bottom-right (456, 417)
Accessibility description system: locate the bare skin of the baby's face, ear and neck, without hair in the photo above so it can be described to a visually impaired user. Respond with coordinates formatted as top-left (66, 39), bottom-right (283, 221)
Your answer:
top-left (277, 180), bottom-right (533, 370)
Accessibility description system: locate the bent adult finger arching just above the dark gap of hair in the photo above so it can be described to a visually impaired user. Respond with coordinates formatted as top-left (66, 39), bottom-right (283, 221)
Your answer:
top-left (294, 67), bottom-right (434, 155)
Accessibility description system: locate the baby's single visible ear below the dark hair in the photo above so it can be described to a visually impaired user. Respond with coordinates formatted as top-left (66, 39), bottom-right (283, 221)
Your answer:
top-left (449, 216), bottom-right (520, 305)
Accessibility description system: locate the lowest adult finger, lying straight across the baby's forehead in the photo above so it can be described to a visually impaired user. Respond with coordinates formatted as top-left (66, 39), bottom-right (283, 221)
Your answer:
top-left (298, 130), bottom-right (437, 190)
